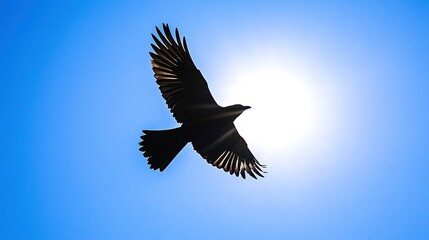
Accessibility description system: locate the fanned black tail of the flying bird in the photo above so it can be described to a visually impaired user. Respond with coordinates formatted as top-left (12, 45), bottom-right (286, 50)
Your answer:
top-left (139, 127), bottom-right (188, 172)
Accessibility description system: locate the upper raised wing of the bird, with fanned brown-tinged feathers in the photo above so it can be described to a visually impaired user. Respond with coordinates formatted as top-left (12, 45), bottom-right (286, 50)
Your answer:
top-left (149, 24), bottom-right (220, 123)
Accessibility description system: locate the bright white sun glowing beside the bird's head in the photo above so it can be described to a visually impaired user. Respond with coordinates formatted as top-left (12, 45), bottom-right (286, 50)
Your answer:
top-left (216, 51), bottom-right (323, 156)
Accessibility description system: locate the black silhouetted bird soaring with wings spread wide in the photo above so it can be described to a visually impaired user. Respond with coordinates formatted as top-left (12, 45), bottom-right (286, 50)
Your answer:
top-left (139, 23), bottom-right (266, 179)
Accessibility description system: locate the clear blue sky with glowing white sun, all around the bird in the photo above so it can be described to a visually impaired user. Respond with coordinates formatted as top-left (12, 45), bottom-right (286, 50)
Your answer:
top-left (0, 0), bottom-right (429, 239)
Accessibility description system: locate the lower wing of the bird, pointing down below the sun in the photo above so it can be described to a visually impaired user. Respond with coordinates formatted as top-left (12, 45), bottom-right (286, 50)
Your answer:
top-left (192, 124), bottom-right (265, 179)
